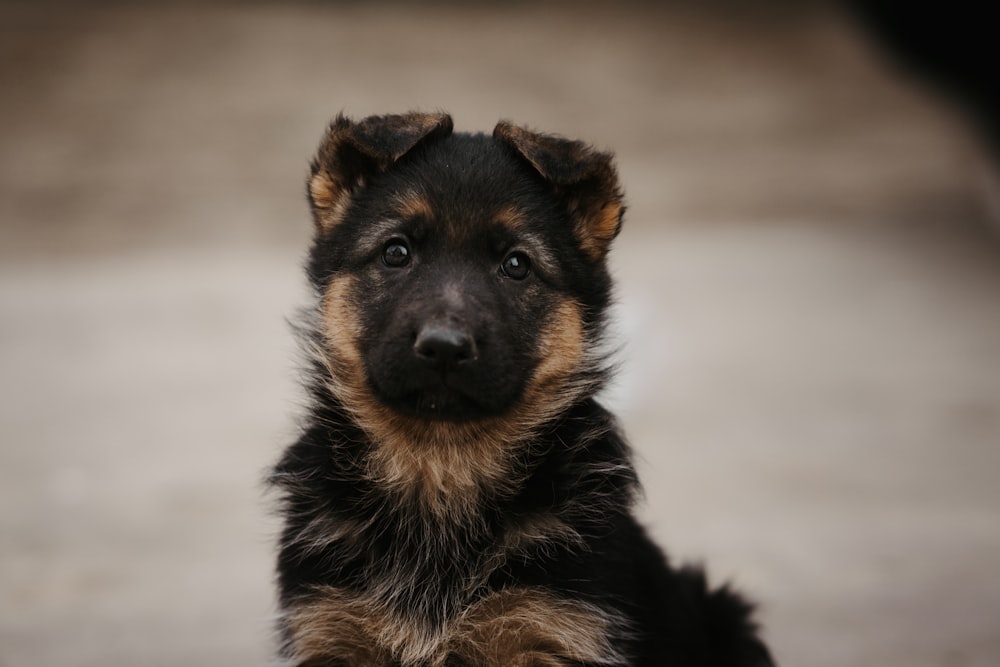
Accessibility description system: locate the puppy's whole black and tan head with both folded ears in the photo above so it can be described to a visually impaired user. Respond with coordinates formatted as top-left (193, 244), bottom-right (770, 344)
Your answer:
top-left (308, 114), bottom-right (623, 448)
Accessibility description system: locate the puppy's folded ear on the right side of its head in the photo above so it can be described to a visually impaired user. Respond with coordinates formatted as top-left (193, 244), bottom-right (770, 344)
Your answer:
top-left (493, 121), bottom-right (625, 261)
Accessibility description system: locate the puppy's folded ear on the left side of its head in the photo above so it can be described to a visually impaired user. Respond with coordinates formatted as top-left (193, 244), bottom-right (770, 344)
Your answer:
top-left (308, 113), bottom-right (452, 233)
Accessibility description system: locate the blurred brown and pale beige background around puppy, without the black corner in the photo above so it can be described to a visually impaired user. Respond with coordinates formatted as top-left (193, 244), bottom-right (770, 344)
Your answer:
top-left (0, 2), bottom-right (1000, 667)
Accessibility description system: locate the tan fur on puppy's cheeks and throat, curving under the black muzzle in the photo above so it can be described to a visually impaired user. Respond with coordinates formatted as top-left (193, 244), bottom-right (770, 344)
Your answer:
top-left (320, 276), bottom-right (585, 519)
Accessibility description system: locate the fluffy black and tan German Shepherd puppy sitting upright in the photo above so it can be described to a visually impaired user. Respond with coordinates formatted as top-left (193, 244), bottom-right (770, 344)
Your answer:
top-left (272, 113), bottom-right (772, 667)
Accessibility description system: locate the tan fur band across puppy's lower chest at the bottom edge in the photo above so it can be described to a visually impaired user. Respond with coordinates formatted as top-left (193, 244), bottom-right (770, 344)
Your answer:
top-left (285, 587), bottom-right (627, 667)
